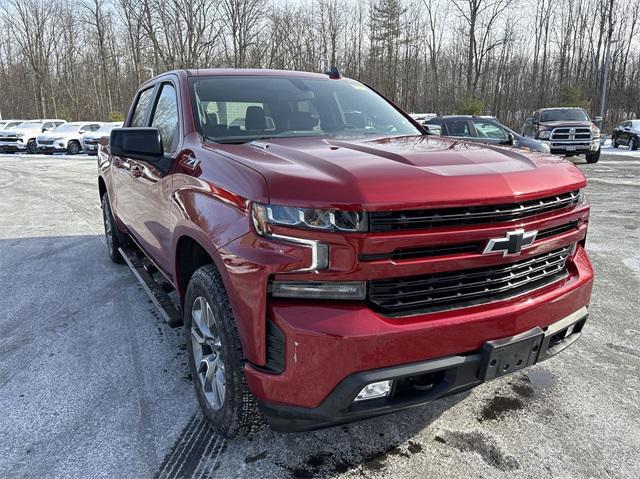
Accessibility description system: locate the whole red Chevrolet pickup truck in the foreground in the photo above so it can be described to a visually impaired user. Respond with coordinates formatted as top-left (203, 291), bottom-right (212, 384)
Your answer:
top-left (98, 70), bottom-right (593, 437)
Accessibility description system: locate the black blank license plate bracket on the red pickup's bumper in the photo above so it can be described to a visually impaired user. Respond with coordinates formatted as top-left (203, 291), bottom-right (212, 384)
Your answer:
top-left (479, 327), bottom-right (544, 381)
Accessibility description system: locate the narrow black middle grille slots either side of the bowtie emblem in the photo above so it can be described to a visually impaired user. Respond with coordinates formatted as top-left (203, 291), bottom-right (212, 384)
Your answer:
top-left (358, 221), bottom-right (580, 262)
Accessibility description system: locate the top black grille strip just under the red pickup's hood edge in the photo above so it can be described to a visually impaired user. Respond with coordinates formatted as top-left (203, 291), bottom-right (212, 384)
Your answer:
top-left (369, 190), bottom-right (579, 232)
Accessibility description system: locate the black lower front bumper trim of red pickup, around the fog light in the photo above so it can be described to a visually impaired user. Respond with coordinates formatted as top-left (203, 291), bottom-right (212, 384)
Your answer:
top-left (262, 307), bottom-right (588, 432)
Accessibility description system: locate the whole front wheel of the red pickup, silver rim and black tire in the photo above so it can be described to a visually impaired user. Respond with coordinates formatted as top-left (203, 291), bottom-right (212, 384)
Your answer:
top-left (184, 265), bottom-right (265, 438)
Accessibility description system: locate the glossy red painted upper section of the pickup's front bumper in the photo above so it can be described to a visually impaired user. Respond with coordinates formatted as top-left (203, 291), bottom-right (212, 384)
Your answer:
top-left (245, 245), bottom-right (593, 409)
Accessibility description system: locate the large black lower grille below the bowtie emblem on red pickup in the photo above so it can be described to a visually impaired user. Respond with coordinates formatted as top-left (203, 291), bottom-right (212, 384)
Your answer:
top-left (368, 246), bottom-right (573, 316)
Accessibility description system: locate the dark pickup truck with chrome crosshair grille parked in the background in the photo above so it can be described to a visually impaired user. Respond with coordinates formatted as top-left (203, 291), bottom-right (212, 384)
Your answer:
top-left (522, 108), bottom-right (600, 163)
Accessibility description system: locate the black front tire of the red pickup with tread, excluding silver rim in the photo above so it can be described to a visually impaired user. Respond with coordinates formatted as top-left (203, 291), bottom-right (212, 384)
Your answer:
top-left (184, 265), bottom-right (266, 438)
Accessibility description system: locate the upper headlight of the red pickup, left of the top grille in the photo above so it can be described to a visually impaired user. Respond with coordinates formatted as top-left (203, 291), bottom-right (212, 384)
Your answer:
top-left (252, 203), bottom-right (367, 235)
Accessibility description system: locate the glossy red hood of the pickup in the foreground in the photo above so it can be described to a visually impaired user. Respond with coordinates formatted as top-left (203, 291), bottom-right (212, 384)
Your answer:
top-left (205, 136), bottom-right (586, 210)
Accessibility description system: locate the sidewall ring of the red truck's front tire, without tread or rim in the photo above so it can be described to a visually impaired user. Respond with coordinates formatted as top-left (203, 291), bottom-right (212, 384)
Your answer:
top-left (184, 266), bottom-right (244, 437)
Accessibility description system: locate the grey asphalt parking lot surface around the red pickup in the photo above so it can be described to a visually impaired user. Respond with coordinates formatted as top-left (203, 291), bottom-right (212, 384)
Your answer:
top-left (0, 151), bottom-right (640, 478)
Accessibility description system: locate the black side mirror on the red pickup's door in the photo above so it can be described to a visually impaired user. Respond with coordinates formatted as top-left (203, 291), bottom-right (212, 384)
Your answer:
top-left (109, 128), bottom-right (164, 161)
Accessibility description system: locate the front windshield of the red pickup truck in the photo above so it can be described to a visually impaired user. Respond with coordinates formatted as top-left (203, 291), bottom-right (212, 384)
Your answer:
top-left (190, 76), bottom-right (422, 143)
